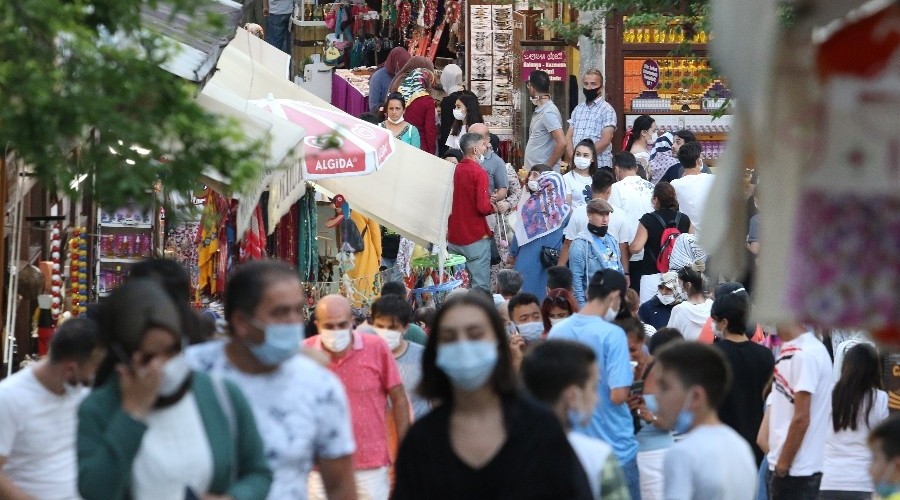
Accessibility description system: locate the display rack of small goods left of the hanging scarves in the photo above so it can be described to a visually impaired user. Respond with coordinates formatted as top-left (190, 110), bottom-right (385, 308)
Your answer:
top-left (94, 204), bottom-right (155, 299)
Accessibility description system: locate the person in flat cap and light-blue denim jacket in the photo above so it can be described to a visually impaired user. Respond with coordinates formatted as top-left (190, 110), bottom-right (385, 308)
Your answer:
top-left (569, 199), bottom-right (623, 307)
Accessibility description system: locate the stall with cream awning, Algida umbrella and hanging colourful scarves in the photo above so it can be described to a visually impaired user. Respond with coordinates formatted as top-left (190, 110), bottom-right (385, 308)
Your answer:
top-left (190, 35), bottom-right (452, 307)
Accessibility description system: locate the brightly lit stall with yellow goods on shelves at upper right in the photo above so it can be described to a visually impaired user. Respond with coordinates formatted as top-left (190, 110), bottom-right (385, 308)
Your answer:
top-left (605, 15), bottom-right (732, 167)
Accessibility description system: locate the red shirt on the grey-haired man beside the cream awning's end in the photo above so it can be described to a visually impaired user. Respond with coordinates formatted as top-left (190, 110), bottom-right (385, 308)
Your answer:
top-left (447, 158), bottom-right (494, 246)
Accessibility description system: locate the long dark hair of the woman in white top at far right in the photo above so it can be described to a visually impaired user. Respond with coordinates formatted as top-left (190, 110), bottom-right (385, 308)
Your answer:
top-left (831, 343), bottom-right (881, 432)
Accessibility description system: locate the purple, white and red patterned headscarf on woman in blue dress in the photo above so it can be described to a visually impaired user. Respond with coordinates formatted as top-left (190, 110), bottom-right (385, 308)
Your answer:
top-left (513, 172), bottom-right (572, 247)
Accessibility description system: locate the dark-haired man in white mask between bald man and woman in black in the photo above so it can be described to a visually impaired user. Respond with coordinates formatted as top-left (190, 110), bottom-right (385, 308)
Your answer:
top-left (372, 295), bottom-right (431, 420)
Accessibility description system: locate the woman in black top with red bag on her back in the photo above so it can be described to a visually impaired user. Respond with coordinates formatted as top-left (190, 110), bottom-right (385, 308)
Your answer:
top-left (628, 182), bottom-right (694, 302)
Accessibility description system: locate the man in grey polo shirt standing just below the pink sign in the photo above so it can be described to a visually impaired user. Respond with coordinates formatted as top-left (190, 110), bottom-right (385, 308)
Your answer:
top-left (525, 70), bottom-right (566, 172)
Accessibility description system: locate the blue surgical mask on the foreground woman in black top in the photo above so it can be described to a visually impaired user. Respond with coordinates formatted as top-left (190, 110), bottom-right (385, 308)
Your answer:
top-left (435, 340), bottom-right (497, 391)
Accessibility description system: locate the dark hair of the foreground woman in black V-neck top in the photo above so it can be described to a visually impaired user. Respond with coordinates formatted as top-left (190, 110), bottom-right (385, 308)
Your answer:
top-left (418, 294), bottom-right (516, 404)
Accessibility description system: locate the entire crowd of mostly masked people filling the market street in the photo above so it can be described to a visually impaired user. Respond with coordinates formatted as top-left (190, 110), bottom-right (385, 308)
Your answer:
top-left (0, 61), bottom-right (900, 500)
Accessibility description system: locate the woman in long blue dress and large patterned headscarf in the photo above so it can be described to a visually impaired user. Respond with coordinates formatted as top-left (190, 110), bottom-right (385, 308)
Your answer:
top-left (507, 165), bottom-right (572, 301)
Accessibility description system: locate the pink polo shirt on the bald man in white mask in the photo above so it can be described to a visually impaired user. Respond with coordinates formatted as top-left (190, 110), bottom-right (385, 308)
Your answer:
top-left (304, 332), bottom-right (403, 470)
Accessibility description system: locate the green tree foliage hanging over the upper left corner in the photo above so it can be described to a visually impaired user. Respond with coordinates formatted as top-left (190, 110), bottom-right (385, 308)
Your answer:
top-left (0, 0), bottom-right (262, 211)
